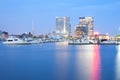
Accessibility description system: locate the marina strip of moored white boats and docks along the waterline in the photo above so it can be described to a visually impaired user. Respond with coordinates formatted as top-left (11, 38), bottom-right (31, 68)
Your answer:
top-left (2, 36), bottom-right (120, 45)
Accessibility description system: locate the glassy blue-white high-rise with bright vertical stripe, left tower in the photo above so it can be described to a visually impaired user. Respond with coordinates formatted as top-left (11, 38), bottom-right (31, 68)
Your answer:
top-left (56, 17), bottom-right (71, 35)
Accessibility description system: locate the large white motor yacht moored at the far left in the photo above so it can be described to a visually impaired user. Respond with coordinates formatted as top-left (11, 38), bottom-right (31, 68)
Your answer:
top-left (3, 37), bottom-right (30, 45)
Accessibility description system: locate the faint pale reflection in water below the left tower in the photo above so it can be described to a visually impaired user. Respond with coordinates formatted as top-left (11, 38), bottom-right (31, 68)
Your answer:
top-left (55, 44), bottom-right (69, 80)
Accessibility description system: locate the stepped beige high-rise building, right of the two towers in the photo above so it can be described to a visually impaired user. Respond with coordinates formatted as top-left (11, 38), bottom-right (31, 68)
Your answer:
top-left (75, 17), bottom-right (94, 36)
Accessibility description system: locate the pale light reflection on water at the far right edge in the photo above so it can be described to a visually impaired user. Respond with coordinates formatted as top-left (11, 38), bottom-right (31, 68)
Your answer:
top-left (116, 45), bottom-right (120, 80)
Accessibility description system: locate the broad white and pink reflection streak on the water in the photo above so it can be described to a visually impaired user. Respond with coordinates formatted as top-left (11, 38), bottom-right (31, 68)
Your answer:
top-left (76, 45), bottom-right (100, 80)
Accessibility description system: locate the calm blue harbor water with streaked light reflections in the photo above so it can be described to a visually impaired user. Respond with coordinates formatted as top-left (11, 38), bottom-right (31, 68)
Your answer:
top-left (0, 43), bottom-right (120, 80)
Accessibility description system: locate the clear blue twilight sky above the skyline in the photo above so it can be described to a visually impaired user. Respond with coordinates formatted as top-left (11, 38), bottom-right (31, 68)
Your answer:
top-left (0, 0), bottom-right (120, 35)
